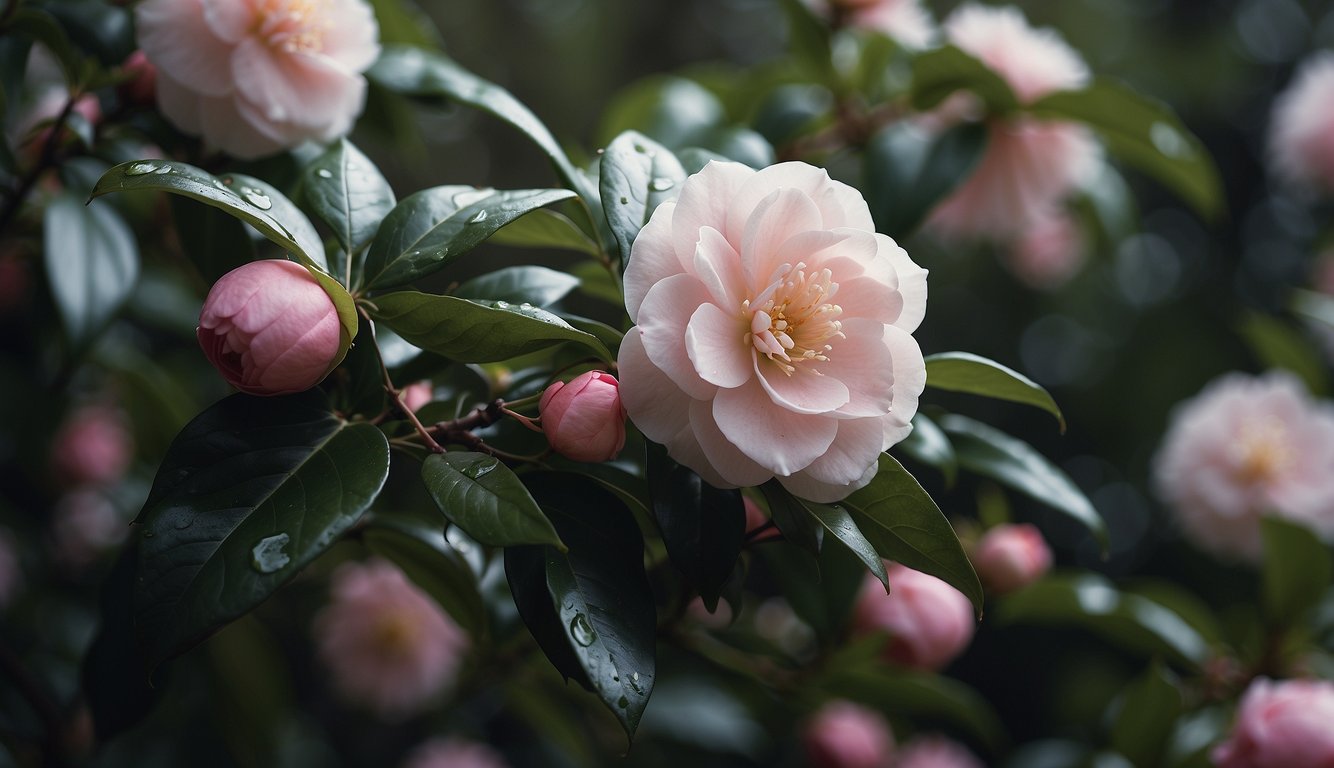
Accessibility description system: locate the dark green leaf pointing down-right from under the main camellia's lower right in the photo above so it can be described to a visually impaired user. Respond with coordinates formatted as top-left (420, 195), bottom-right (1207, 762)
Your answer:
top-left (842, 453), bottom-right (982, 616)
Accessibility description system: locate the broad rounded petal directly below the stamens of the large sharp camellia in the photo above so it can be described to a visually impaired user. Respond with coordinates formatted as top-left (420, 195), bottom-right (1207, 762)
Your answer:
top-left (714, 381), bottom-right (838, 475)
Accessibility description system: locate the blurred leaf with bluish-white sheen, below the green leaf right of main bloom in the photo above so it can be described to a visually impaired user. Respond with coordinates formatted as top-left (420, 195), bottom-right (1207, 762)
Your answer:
top-left (940, 413), bottom-right (1107, 548)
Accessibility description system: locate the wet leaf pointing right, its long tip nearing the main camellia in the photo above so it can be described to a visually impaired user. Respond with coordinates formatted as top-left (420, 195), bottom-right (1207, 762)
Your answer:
top-left (366, 187), bottom-right (574, 288)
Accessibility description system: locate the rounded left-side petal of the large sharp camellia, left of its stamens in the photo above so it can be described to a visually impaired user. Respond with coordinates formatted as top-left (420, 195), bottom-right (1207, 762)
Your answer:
top-left (639, 275), bottom-right (715, 400)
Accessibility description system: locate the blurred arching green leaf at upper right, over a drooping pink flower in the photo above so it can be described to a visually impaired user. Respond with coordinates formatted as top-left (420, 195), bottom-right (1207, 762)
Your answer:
top-left (1029, 80), bottom-right (1225, 219)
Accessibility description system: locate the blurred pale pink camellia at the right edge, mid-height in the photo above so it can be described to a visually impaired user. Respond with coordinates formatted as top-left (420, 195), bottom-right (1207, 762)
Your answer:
top-left (1154, 372), bottom-right (1334, 561)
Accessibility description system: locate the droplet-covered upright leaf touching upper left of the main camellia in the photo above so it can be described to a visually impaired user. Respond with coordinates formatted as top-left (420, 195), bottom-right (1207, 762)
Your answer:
top-left (599, 131), bottom-right (686, 265)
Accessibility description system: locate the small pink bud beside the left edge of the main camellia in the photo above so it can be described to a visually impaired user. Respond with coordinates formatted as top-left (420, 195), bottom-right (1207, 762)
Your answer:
top-left (538, 371), bottom-right (626, 461)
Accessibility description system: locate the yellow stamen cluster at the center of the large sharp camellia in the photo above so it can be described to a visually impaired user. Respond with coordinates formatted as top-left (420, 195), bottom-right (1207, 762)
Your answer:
top-left (742, 261), bottom-right (843, 376)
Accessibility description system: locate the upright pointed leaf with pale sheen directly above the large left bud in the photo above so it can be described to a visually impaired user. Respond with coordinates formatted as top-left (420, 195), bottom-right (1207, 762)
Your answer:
top-left (301, 139), bottom-right (396, 272)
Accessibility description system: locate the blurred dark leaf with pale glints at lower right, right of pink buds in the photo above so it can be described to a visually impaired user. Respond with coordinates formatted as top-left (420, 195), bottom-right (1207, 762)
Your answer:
top-left (996, 573), bottom-right (1210, 668)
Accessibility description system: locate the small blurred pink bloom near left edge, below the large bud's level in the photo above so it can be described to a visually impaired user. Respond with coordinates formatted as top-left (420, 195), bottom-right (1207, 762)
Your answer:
top-left (51, 405), bottom-right (135, 487)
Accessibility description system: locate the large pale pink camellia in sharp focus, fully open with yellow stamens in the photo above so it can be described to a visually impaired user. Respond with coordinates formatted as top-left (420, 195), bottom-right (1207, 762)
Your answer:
top-left (619, 163), bottom-right (926, 501)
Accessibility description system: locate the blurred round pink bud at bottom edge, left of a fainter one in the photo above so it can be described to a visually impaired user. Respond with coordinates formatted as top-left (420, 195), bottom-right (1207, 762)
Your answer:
top-left (802, 700), bottom-right (894, 768)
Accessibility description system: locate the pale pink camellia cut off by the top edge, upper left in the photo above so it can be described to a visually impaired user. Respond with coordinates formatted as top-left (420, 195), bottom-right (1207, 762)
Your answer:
top-left (135, 0), bottom-right (380, 159)
